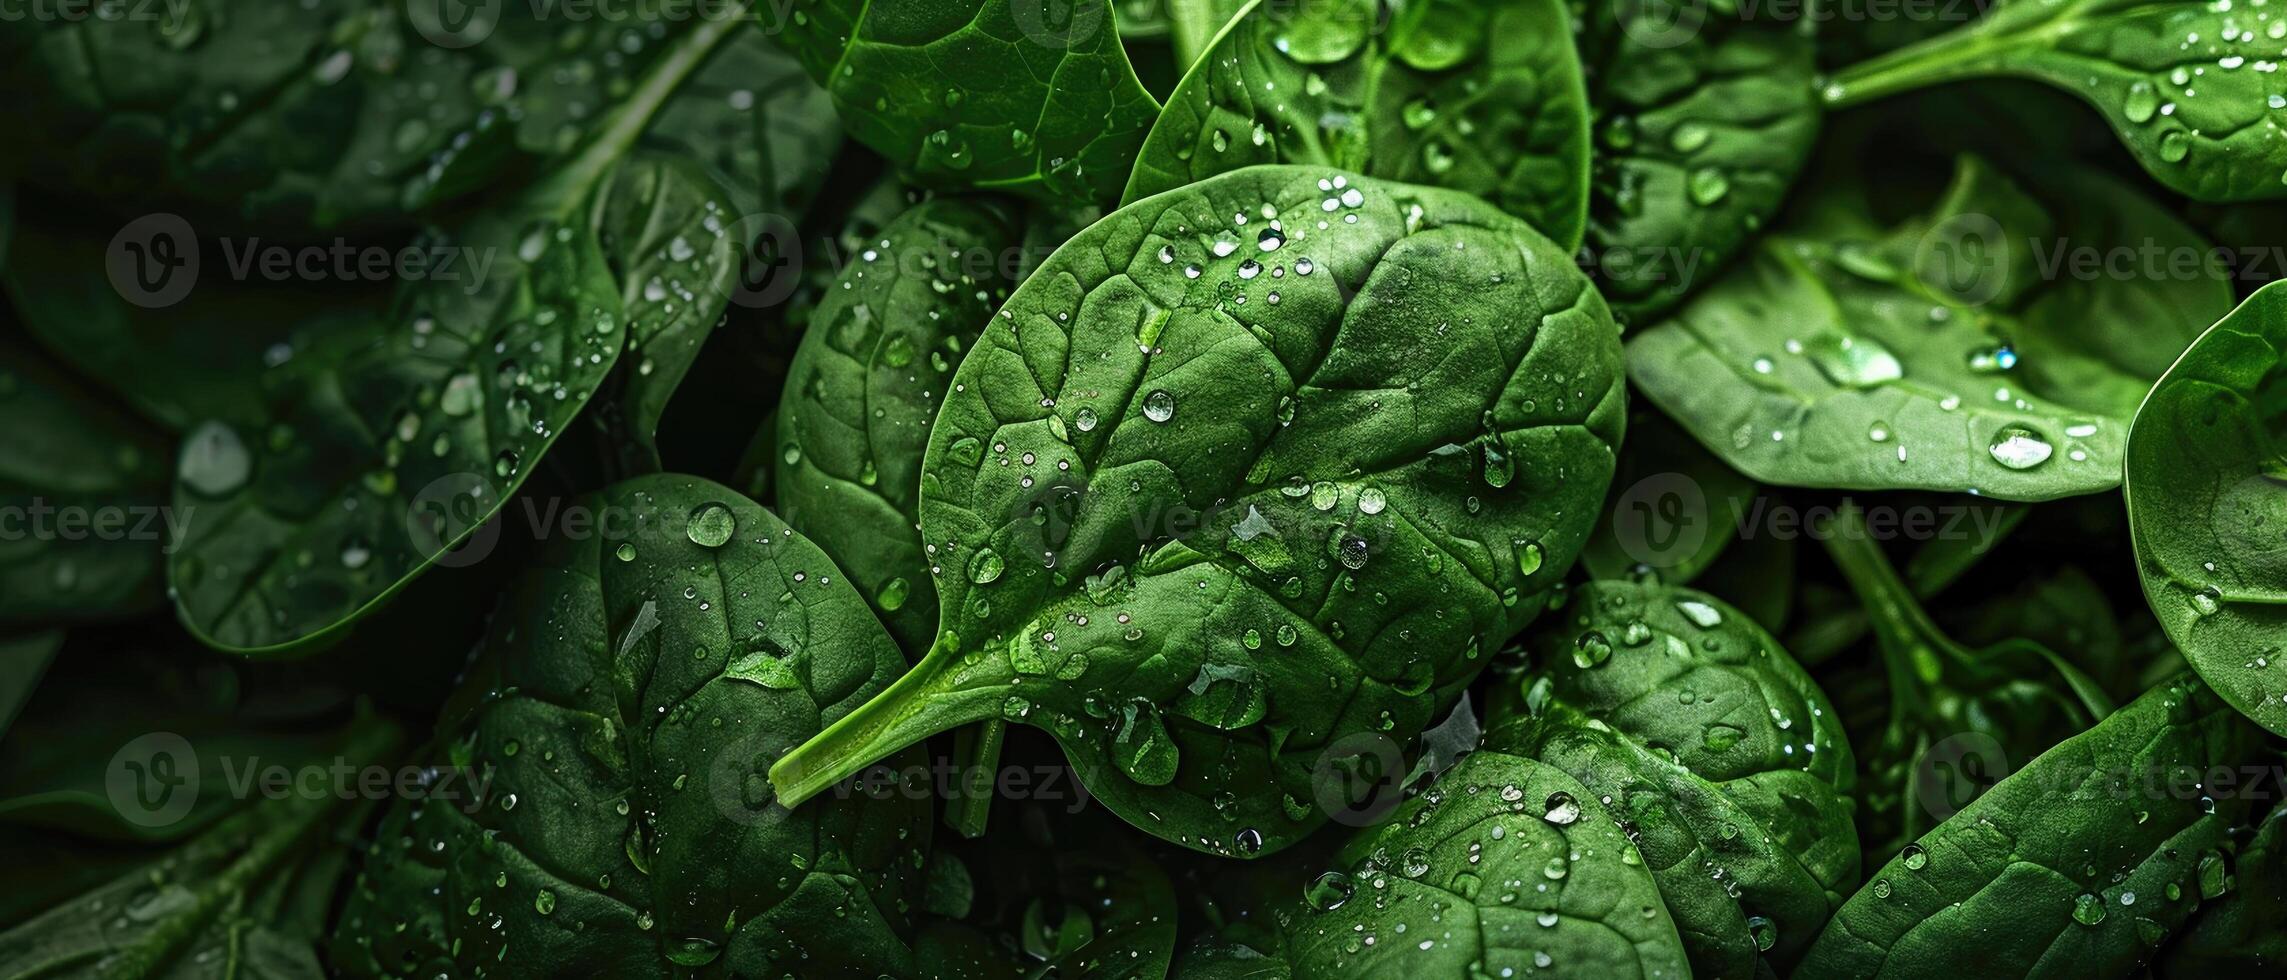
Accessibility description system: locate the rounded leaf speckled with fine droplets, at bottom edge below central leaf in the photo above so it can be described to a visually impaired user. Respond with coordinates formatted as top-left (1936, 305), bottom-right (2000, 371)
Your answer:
top-left (1283, 747), bottom-right (1690, 978)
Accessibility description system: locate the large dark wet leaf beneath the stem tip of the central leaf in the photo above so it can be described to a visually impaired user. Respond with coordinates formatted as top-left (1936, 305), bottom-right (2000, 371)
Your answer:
top-left (334, 475), bottom-right (929, 978)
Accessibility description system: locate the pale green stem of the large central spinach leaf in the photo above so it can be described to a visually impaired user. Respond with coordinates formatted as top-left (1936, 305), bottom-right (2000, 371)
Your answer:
top-left (771, 637), bottom-right (1011, 806)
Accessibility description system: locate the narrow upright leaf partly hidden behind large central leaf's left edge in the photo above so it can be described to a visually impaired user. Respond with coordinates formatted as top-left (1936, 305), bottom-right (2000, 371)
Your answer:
top-left (775, 199), bottom-right (1018, 653)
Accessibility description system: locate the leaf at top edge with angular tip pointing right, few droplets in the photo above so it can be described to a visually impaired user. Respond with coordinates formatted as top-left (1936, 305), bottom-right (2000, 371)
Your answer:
top-left (764, 0), bottom-right (1160, 203)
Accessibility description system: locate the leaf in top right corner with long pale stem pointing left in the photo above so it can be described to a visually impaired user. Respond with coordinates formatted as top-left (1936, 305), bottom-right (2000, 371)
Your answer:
top-left (1820, 0), bottom-right (2287, 201)
